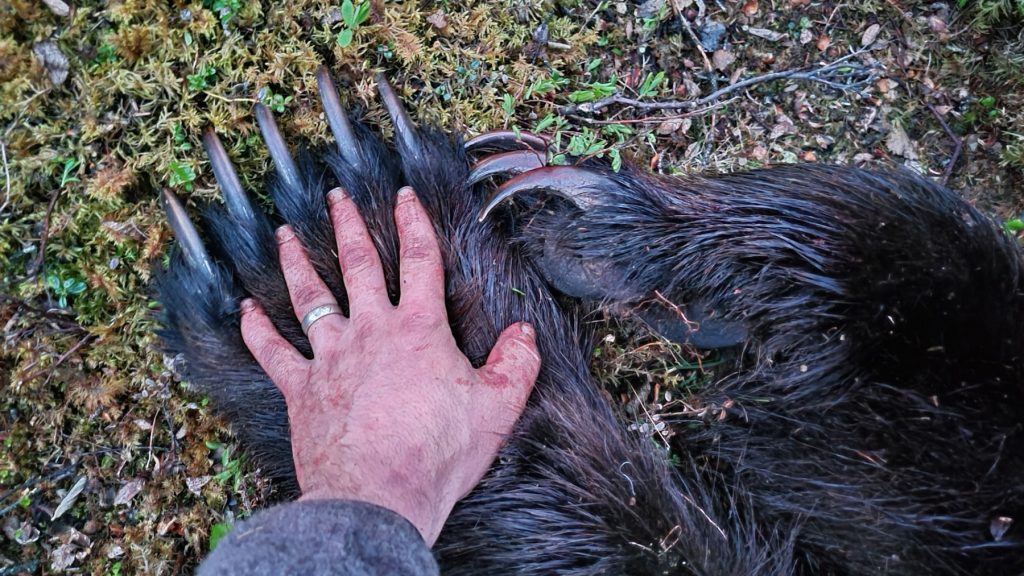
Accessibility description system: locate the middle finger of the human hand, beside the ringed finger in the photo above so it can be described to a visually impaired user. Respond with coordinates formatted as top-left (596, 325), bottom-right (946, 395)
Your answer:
top-left (328, 188), bottom-right (392, 318)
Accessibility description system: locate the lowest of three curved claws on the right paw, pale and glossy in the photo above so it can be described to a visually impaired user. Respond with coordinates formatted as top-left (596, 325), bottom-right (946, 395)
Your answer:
top-left (478, 166), bottom-right (615, 222)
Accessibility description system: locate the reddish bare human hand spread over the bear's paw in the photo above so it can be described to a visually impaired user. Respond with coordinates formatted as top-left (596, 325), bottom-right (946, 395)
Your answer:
top-left (242, 188), bottom-right (541, 545)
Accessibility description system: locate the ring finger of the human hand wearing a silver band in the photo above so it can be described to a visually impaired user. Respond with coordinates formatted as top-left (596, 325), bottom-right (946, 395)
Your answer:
top-left (276, 224), bottom-right (344, 354)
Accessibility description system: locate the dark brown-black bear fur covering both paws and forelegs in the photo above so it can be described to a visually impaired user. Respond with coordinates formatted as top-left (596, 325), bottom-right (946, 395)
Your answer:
top-left (151, 75), bottom-right (1024, 576)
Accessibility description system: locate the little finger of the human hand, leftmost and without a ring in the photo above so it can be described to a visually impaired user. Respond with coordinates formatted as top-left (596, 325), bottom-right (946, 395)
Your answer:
top-left (242, 298), bottom-right (308, 402)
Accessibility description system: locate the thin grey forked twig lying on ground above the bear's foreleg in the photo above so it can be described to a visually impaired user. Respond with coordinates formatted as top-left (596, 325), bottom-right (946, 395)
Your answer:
top-left (555, 50), bottom-right (880, 116)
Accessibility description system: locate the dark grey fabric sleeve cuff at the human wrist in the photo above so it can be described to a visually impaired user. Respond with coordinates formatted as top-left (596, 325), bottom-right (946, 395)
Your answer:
top-left (197, 500), bottom-right (439, 576)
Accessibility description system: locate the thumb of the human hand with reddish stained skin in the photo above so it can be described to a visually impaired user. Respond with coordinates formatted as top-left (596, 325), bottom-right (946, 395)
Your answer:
top-left (479, 322), bottom-right (541, 435)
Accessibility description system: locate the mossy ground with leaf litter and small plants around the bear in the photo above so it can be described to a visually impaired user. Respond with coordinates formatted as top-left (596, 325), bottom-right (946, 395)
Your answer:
top-left (0, 0), bottom-right (1024, 574)
